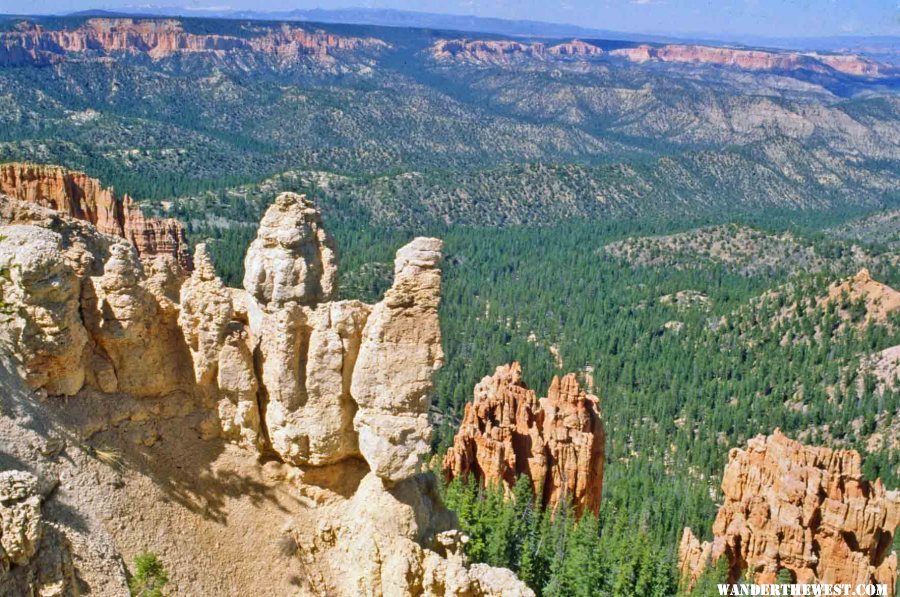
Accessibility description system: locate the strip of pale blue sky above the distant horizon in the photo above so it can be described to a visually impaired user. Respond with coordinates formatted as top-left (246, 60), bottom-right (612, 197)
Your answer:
top-left (7, 0), bottom-right (900, 37)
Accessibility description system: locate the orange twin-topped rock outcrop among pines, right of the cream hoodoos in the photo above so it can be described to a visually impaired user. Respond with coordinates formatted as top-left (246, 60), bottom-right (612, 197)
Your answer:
top-left (443, 363), bottom-right (606, 514)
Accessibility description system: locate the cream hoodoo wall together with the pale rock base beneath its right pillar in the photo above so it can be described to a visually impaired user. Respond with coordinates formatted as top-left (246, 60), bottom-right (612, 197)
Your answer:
top-left (0, 185), bottom-right (528, 596)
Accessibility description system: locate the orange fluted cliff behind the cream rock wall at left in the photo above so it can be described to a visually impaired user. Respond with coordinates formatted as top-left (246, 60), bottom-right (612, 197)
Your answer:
top-left (0, 162), bottom-right (191, 270)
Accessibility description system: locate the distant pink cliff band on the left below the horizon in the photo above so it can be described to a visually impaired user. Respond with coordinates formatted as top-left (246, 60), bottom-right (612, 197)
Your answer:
top-left (0, 18), bottom-right (387, 66)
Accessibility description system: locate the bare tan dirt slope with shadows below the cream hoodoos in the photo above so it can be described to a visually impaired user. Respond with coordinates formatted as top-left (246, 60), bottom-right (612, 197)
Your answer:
top-left (0, 352), bottom-right (342, 596)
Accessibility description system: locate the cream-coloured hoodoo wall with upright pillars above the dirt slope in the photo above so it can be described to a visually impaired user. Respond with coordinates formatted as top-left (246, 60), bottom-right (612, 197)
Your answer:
top-left (0, 189), bottom-right (443, 482)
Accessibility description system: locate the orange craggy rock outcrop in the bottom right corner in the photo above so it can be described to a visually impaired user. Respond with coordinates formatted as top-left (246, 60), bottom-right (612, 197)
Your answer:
top-left (679, 430), bottom-right (900, 594)
